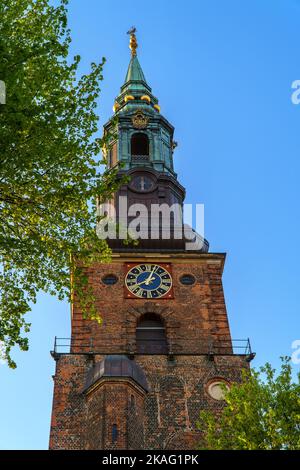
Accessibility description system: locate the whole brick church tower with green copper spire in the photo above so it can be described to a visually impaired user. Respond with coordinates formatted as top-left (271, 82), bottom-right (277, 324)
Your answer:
top-left (50, 29), bottom-right (254, 450)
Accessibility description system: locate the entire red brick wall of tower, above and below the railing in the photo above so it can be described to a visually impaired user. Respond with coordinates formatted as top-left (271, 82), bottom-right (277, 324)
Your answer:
top-left (50, 254), bottom-right (248, 450)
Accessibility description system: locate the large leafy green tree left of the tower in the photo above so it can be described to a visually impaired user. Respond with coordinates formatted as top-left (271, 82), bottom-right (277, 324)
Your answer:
top-left (0, 0), bottom-right (117, 367)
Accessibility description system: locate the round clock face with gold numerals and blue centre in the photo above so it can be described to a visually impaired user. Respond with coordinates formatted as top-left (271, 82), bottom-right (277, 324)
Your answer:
top-left (125, 263), bottom-right (172, 299)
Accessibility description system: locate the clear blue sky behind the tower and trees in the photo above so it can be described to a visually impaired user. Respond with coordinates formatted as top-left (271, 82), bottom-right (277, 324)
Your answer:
top-left (0, 0), bottom-right (300, 449)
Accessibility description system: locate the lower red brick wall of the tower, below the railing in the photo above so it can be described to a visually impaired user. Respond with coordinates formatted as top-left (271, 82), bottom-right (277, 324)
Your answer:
top-left (50, 355), bottom-right (248, 450)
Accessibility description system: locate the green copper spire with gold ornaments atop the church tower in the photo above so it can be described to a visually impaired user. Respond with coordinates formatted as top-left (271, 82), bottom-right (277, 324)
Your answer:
top-left (104, 28), bottom-right (176, 178)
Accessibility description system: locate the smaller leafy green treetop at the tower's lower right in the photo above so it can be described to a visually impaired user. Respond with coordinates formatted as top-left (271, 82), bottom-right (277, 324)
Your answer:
top-left (198, 358), bottom-right (300, 450)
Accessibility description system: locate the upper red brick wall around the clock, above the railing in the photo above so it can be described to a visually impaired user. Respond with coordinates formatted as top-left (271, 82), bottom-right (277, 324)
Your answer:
top-left (72, 255), bottom-right (230, 353)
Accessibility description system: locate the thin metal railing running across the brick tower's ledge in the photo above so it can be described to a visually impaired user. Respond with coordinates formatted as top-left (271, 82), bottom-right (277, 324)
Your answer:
top-left (52, 337), bottom-right (255, 361)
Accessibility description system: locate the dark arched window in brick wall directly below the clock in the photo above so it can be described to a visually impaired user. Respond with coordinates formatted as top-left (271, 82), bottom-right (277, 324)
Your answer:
top-left (136, 313), bottom-right (168, 354)
